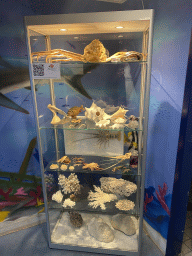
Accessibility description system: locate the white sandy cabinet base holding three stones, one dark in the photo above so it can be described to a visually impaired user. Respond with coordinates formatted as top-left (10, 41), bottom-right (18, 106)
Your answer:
top-left (51, 210), bottom-right (139, 252)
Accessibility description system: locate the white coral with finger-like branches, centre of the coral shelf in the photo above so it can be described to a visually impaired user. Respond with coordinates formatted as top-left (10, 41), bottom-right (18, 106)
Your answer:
top-left (88, 185), bottom-right (117, 210)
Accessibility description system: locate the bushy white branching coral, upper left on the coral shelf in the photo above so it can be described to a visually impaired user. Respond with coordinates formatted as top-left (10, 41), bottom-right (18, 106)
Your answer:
top-left (58, 173), bottom-right (80, 194)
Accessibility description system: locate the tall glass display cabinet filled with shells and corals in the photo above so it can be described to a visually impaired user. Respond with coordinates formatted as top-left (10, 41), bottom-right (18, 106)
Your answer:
top-left (25, 10), bottom-right (153, 255)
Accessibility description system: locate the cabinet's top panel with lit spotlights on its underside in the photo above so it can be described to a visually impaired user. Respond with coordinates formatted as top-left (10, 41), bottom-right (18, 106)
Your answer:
top-left (25, 10), bottom-right (153, 35)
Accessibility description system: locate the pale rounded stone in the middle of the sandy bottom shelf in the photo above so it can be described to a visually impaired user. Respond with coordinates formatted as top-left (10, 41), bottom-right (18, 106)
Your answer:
top-left (87, 217), bottom-right (115, 243)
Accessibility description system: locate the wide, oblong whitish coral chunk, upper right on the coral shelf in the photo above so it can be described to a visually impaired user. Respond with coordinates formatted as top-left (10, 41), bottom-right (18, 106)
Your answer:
top-left (100, 177), bottom-right (137, 196)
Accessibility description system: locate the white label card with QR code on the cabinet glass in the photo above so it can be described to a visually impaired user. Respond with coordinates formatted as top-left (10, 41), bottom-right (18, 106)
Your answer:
top-left (32, 63), bottom-right (61, 79)
